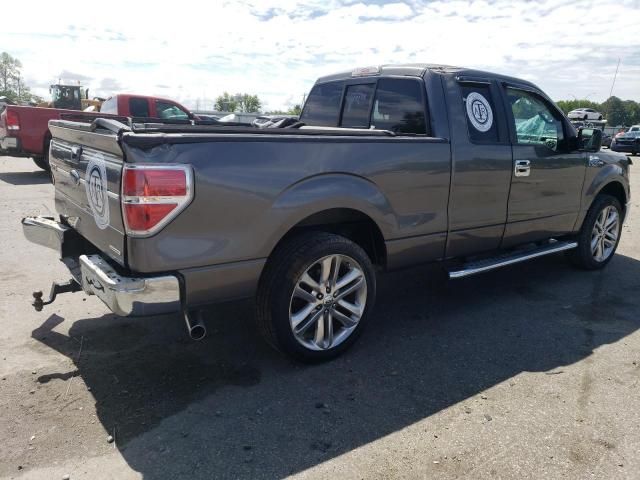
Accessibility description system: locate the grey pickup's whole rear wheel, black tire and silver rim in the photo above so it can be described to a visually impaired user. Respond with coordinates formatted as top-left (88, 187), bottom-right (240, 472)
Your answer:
top-left (256, 232), bottom-right (376, 363)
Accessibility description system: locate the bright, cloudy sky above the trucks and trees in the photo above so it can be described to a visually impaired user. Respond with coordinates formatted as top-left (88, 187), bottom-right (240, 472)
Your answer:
top-left (0, 0), bottom-right (640, 110)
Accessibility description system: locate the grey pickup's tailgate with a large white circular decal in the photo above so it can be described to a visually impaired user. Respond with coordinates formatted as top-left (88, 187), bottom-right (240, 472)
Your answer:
top-left (49, 121), bottom-right (125, 265)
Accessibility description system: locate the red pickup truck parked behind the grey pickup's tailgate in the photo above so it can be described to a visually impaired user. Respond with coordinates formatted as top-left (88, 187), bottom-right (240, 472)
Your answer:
top-left (0, 94), bottom-right (197, 170)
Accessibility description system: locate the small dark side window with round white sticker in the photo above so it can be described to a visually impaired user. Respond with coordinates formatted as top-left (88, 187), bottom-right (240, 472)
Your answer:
top-left (460, 84), bottom-right (499, 143)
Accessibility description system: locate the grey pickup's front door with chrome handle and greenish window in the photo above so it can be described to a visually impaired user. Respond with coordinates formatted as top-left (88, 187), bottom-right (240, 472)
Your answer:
top-left (502, 86), bottom-right (586, 247)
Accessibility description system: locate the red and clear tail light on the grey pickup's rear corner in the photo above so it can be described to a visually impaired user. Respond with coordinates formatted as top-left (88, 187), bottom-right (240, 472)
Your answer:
top-left (122, 165), bottom-right (193, 237)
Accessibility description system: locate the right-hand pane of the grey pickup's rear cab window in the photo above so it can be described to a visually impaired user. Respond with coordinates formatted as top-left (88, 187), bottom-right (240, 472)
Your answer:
top-left (370, 78), bottom-right (427, 134)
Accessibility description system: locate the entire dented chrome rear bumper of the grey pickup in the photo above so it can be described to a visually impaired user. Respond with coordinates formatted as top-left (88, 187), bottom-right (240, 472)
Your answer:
top-left (22, 217), bottom-right (181, 317)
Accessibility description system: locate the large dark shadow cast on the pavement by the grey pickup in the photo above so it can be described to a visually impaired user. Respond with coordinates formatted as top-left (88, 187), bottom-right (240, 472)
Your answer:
top-left (33, 255), bottom-right (640, 479)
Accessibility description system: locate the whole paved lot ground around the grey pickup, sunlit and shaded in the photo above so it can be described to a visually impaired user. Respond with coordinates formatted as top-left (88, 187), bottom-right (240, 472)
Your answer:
top-left (0, 157), bottom-right (640, 480)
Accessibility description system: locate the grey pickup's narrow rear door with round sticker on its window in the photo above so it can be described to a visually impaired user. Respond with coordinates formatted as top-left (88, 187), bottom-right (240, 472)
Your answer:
top-left (445, 75), bottom-right (512, 257)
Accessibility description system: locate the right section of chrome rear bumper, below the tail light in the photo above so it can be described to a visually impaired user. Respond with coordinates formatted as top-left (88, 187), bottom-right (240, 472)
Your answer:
top-left (80, 255), bottom-right (180, 317)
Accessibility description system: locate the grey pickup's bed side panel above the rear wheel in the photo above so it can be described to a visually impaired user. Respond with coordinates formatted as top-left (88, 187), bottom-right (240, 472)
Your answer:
top-left (123, 134), bottom-right (450, 272)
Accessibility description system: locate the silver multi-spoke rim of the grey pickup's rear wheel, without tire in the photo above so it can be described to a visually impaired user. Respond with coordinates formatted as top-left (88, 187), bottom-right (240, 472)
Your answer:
top-left (289, 255), bottom-right (367, 350)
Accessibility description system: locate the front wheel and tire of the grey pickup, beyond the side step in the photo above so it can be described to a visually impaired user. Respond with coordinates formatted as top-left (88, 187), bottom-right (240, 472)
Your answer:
top-left (568, 195), bottom-right (622, 270)
